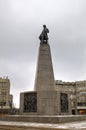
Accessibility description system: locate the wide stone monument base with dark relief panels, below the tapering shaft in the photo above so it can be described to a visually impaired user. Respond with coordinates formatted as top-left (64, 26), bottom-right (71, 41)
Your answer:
top-left (20, 91), bottom-right (70, 115)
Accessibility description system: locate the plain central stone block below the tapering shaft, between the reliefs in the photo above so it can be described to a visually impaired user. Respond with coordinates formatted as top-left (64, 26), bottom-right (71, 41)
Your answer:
top-left (37, 91), bottom-right (60, 115)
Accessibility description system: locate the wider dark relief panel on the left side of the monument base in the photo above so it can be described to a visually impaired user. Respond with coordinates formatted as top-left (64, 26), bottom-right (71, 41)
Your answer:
top-left (24, 92), bottom-right (37, 112)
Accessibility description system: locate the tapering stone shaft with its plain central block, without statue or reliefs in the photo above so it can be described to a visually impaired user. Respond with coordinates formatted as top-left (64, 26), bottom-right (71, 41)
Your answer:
top-left (35, 43), bottom-right (59, 115)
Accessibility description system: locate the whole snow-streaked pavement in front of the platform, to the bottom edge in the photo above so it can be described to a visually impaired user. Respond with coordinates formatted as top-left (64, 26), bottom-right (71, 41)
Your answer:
top-left (0, 121), bottom-right (86, 130)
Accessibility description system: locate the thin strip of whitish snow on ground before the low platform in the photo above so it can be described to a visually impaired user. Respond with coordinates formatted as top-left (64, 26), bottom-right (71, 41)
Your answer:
top-left (0, 121), bottom-right (86, 130)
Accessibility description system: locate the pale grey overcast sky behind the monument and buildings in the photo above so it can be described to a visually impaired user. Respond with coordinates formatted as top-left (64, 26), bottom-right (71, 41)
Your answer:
top-left (0, 0), bottom-right (86, 107)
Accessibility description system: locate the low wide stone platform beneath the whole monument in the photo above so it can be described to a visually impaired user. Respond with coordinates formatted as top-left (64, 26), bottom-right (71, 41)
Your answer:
top-left (0, 115), bottom-right (86, 124)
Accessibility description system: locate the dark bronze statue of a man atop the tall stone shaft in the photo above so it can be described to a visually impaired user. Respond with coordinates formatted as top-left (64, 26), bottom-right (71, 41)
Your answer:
top-left (39, 25), bottom-right (49, 44)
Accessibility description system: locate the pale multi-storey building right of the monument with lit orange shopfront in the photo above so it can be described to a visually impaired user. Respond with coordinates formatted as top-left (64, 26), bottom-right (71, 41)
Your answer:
top-left (55, 80), bottom-right (86, 114)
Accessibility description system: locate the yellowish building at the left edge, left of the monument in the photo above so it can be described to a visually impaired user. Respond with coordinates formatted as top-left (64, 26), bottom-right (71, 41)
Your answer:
top-left (0, 77), bottom-right (13, 109)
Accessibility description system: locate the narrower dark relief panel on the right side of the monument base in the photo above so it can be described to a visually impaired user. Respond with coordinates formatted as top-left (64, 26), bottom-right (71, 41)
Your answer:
top-left (60, 93), bottom-right (68, 112)
